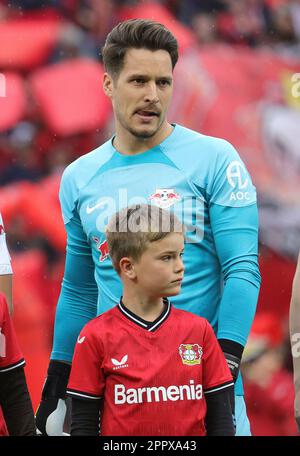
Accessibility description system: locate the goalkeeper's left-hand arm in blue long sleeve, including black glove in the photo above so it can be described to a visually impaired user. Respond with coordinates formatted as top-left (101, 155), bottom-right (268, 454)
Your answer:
top-left (36, 217), bottom-right (98, 435)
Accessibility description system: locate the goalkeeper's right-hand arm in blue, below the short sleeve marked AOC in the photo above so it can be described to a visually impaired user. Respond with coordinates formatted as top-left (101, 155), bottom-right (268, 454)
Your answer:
top-left (210, 204), bottom-right (260, 388)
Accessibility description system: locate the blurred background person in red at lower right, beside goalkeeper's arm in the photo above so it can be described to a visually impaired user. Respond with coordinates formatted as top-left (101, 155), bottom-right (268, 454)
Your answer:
top-left (241, 311), bottom-right (297, 436)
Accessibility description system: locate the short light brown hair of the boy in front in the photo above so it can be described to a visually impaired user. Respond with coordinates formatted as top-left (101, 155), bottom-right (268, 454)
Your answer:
top-left (106, 204), bottom-right (184, 274)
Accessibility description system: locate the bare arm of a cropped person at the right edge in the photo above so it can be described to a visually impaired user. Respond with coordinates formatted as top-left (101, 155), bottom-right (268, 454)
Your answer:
top-left (290, 252), bottom-right (300, 432)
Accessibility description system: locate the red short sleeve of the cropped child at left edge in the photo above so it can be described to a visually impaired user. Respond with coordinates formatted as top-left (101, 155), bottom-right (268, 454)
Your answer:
top-left (0, 294), bottom-right (25, 374)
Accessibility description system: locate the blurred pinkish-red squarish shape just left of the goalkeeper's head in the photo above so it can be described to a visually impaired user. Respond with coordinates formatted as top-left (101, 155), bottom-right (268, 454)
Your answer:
top-left (31, 59), bottom-right (111, 136)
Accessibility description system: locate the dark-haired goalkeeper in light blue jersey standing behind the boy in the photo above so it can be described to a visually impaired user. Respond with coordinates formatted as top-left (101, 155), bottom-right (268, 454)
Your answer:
top-left (36, 19), bottom-right (260, 435)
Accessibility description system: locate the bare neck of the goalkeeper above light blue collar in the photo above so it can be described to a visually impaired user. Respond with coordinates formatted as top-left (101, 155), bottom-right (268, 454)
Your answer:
top-left (113, 123), bottom-right (174, 155)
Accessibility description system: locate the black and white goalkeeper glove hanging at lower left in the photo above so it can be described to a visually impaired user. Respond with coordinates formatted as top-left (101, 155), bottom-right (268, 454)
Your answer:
top-left (35, 360), bottom-right (71, 436)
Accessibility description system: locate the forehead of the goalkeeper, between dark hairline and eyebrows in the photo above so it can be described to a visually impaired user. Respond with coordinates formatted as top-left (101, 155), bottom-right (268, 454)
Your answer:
top-left (122, 48), bottom-right (172, 76)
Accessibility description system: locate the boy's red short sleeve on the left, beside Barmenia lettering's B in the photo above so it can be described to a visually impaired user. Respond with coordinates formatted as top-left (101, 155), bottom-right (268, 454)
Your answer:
top-left (67, 324), bottom-right (105, 400)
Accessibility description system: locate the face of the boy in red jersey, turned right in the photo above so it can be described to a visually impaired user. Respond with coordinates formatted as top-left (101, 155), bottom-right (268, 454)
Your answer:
top-left (134, 233), bottom-right (184, 297)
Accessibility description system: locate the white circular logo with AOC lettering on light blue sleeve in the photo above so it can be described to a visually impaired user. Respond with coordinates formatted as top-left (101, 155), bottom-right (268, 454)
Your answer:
top-left (226, 160), bottom-right (251, 201)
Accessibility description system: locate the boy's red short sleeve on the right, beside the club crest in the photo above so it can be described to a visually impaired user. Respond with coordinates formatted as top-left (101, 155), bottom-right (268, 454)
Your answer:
top-left (202, 321), bottom-right (233, 394)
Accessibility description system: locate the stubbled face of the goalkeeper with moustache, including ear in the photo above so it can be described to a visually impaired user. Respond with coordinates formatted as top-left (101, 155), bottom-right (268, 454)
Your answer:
top-left (104, 48), bottom-right (173, 139)
